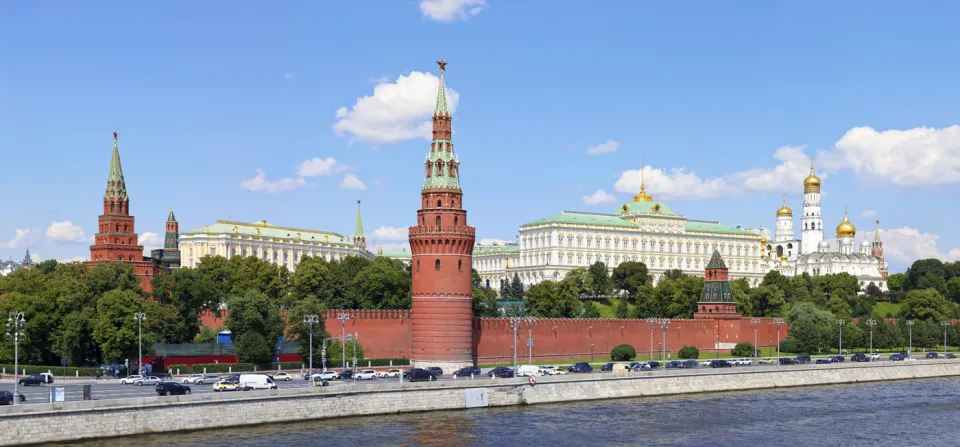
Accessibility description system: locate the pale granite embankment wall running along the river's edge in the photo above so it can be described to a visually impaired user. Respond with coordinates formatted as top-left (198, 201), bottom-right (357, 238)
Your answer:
top-left (0, 360), bottom-right (960, 445)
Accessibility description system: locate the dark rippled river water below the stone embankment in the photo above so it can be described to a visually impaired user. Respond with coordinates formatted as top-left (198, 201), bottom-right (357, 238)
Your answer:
top-left (62, 378), bottom-right (960, 447)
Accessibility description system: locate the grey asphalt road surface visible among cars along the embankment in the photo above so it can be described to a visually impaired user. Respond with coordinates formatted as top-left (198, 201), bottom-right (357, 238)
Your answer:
top-left (0, 359), bottom-right (936, 405)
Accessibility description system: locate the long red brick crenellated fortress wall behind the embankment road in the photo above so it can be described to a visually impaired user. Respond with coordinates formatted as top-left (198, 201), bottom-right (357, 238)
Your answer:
top-left (202, 310), bottom-right (787, 363)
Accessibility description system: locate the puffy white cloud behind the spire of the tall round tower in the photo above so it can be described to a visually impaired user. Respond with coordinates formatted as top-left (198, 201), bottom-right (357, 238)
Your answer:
top-left (333, 71), bottom-right (460, 144)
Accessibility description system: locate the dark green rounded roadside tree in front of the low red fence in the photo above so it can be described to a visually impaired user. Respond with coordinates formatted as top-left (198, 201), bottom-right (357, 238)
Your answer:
top-left (226, 290), bottom-right (283, 363)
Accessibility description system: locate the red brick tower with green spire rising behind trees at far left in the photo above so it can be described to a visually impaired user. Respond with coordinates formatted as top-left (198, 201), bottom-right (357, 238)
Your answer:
top-left (87, 131), bottom-right (158, 293)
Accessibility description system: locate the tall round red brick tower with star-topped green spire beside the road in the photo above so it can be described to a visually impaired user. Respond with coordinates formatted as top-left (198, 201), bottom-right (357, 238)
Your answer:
top-left (410, 59), bottom-right (475, 370)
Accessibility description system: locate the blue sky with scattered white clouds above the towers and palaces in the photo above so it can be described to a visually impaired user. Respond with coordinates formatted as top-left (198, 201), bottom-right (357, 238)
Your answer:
top-left (0, 0), bottom-right (960, 270)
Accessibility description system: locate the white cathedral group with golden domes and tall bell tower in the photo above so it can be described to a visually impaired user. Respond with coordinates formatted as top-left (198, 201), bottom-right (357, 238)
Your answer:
top-left (761, 159), bottom-right (888, 291)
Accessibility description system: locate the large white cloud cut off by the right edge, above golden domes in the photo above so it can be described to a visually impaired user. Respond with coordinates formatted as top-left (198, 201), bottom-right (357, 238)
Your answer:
top-left (821, 125), bottom-right (960, 186)
